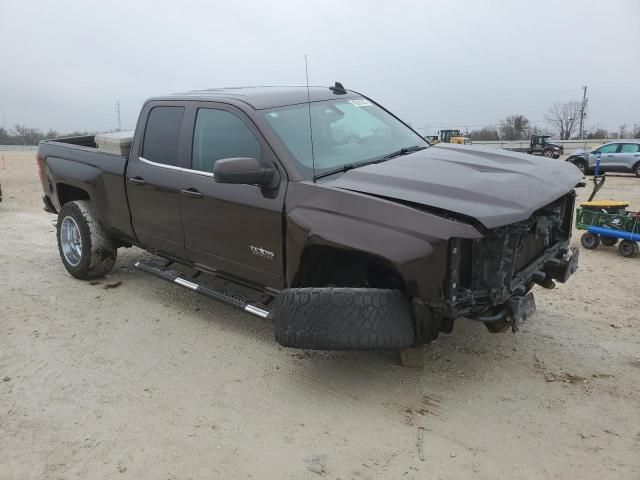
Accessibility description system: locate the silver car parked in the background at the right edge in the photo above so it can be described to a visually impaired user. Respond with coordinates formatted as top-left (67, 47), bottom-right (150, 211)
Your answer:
top-left (567, 140), bottom-right (640, 177)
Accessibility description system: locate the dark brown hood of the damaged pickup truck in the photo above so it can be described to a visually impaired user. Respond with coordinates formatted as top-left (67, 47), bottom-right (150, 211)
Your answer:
top-left (325, 144), bottom-right (582, 228)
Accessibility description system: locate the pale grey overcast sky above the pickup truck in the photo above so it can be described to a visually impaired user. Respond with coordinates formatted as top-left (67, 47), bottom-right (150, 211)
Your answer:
top-left (0, 0), bottom-right (640, 133)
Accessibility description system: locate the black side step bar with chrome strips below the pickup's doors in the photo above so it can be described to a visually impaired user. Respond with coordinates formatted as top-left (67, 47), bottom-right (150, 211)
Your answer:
top-left (134, 261), bottom-right (269, 318)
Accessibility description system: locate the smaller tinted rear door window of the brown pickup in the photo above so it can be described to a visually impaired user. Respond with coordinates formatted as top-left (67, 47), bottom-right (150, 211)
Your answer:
top-left (142, 107), bottom-right (184, 167)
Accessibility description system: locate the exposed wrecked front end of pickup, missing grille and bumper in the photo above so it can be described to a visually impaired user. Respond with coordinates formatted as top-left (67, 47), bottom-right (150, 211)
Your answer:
top-left (441, 192), bottom-right (579, 331)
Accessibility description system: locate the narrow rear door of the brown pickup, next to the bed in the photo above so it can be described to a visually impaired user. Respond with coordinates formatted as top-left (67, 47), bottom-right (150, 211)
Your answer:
top-left (126, 102), bottom-right (186, 259)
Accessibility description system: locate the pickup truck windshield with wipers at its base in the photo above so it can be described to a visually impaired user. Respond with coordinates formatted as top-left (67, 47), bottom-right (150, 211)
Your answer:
top-left (264, 98), bottom-right (429, 179)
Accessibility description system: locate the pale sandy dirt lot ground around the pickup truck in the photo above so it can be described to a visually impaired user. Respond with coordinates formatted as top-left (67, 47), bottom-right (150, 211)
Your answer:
top-left (0, 152), bottom-right (640, 480)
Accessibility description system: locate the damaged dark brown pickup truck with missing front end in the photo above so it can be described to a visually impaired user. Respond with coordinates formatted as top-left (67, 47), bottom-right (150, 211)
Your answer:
top-left (37, 83), bottom-right (581, 360)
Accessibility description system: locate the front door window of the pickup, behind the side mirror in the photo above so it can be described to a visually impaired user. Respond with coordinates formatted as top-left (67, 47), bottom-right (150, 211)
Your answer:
top-left (191, 108), bottom-right (260, 172)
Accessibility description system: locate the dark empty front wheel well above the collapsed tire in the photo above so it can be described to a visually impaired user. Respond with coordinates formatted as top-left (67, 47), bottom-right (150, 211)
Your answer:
top-left (292, 246), bottom-right (405, 290)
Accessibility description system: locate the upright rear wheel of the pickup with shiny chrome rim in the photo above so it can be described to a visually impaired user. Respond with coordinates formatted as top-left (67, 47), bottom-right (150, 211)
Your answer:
top-left (56, 200), bottom-right (117, 280)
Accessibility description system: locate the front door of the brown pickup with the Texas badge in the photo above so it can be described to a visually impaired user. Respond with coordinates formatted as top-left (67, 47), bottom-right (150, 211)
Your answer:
top-left (180, 104), bottom-right (286, 288)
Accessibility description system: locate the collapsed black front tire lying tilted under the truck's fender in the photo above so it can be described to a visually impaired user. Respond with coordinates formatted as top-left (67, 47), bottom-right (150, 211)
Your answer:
top-left (272, 288), bottom-right (415, 350)
